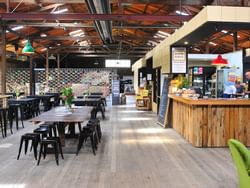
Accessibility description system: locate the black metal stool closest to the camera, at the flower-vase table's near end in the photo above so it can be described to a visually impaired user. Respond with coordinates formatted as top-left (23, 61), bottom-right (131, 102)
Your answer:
top-left (37, 137), bottom-right (64, 166)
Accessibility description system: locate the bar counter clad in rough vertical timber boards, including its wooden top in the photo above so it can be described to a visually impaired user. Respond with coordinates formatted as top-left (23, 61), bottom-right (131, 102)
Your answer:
top-left (169, 95), bottom-right (250, 147)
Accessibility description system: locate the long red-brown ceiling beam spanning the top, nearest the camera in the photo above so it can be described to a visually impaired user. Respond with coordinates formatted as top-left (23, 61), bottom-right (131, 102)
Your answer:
top-left (0, 13), bottom-right (192, 22)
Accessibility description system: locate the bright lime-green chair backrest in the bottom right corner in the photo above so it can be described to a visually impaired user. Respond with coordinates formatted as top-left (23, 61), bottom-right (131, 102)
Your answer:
top-left (228, 139), bottom-right (250, 188)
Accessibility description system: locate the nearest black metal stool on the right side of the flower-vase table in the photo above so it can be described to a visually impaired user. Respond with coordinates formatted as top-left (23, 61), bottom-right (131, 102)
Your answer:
top-left (76, 126), bottom-right (97, 155)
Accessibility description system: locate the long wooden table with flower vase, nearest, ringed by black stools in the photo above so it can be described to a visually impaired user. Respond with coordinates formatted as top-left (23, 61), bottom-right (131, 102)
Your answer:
top-left (29, 106), bottom-right (93, 146)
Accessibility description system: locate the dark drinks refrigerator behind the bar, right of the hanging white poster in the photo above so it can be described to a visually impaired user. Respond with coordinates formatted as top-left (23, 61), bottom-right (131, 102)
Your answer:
top-left (189, 66), bottom-right (216, 97)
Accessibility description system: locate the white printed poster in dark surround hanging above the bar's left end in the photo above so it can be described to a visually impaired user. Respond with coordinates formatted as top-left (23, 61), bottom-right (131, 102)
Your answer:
top-left (170, 47), bottom-right (188, 74)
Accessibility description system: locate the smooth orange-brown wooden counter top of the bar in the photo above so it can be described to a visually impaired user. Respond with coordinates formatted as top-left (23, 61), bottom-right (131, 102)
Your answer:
top-left (168, 94), bottom-right (250, 106)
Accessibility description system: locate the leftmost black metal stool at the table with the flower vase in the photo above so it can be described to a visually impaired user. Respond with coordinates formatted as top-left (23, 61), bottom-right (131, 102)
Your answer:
top-left (17, 133), bottom-right (40, 160)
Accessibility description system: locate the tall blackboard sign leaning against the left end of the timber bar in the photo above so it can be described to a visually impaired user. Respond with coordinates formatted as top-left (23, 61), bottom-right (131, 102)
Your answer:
top-left (158, 77), bottom-right (171, 127)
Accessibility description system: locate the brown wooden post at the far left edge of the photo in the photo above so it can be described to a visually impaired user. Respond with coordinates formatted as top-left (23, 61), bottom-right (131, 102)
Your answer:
top-left (1, 26), bottom-right (6, 94)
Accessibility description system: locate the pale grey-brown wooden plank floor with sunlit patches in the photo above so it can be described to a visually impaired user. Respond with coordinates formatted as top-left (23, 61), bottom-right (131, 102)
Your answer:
top-left (0, 97), bottom-right (237, 188)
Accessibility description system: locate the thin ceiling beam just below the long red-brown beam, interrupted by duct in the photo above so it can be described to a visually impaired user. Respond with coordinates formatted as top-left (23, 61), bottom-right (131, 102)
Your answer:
top-left (7, 22), bottom-right (179, 29)
